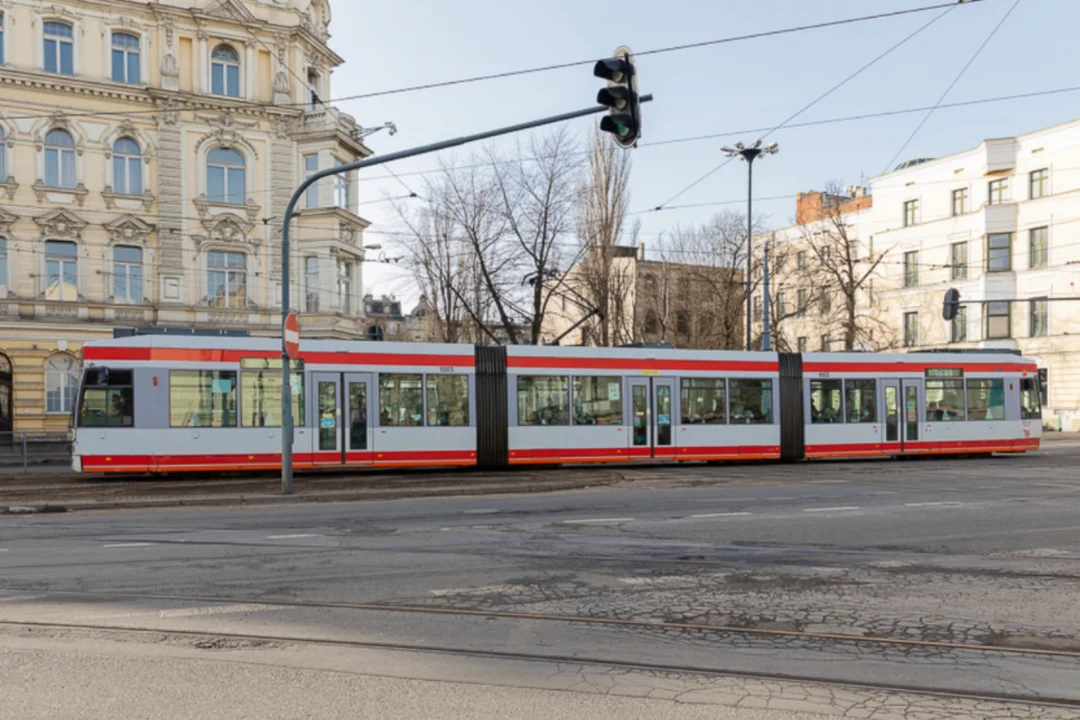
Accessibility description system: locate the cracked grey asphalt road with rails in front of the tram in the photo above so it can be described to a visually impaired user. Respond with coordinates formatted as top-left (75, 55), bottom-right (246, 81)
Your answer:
top-left (0, 445), bottom-right (1080, 720)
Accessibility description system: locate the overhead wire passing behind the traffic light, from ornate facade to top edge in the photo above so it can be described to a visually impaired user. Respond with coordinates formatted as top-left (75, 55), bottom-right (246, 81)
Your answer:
top-left (8, 0), bottom-right (986, 120)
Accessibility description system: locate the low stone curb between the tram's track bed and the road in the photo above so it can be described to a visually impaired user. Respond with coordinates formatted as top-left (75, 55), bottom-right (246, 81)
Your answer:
top-left (0, 479), bottom-right (605, 515)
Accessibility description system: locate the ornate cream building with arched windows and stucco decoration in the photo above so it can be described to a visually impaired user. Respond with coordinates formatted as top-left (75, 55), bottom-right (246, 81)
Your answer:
top-left (0, 0), bottom-right (370, 432)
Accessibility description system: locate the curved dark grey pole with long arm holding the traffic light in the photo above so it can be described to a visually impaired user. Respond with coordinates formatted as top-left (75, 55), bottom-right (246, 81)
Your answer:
top-left (281, 95), bottom-right (652, 495)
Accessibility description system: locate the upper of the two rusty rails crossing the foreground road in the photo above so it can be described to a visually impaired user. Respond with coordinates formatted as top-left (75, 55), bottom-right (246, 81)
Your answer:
top-left (0, 588), bottom-right (1080, 661)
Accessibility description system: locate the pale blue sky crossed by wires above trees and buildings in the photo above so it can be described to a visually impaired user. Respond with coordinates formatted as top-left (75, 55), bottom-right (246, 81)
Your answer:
top-left (319, 0), bottom-right (1080, 305)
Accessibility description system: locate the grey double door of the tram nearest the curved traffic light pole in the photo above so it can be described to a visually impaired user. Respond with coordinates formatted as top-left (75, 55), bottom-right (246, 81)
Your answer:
top-left (311, 372), bottom-right (373, 465)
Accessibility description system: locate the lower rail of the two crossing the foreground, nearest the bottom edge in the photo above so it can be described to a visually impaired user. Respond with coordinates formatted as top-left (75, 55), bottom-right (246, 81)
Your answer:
top-left (0, 617), bottom-right (1080, 710)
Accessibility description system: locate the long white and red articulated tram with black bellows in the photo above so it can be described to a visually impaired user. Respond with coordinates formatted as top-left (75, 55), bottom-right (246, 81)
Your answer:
top-left (72, 335), bottom-right (1042, 473)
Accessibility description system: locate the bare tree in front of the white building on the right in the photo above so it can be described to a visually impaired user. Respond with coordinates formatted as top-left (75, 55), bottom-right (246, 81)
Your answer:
top-left (801, 182), bottom-right (894, 351)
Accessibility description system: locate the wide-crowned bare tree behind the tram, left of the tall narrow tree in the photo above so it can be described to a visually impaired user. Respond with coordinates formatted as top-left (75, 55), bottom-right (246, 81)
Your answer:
top-left (397, 131), bottom-right (581, 344)
